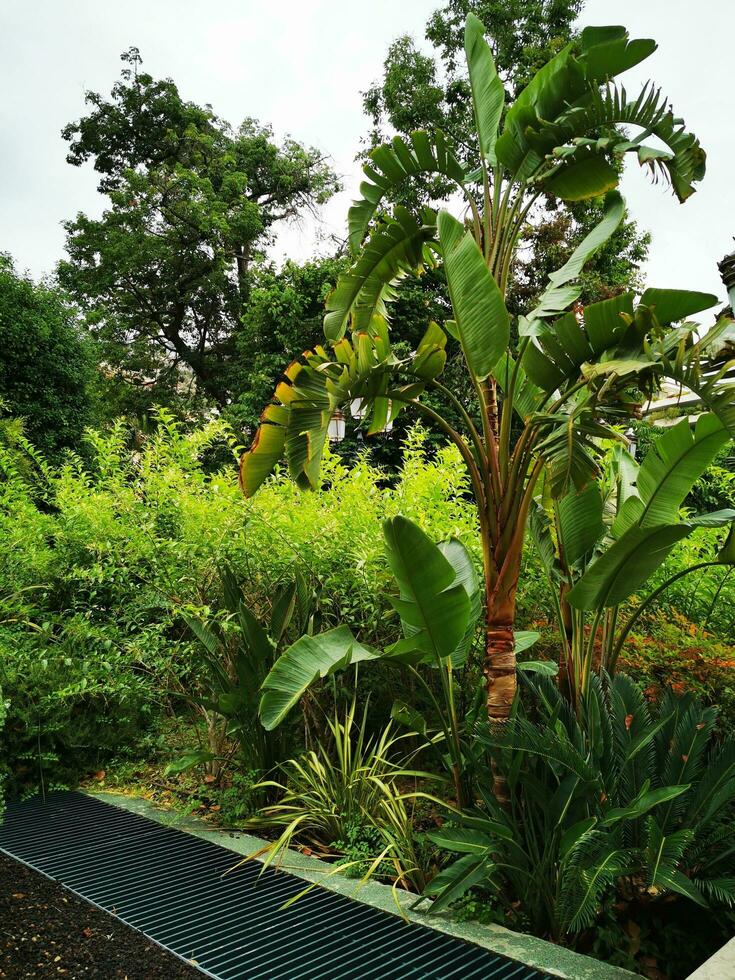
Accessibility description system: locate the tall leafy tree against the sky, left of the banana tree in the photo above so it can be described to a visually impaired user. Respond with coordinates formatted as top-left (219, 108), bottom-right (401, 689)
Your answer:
top-left (59, 48), bottom-right (338, 405)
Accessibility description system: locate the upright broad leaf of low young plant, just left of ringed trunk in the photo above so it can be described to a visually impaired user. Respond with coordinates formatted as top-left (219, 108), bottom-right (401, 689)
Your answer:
top-left (383, 517), bottom-right (476, 665)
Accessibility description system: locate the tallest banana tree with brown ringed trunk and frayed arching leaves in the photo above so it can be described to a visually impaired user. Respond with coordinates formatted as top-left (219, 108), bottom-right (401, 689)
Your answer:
top-left (241, 15), bottom-right (724, 793)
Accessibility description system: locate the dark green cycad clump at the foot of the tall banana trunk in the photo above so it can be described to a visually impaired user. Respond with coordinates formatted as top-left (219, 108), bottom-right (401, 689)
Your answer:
top-left (426, 674), bottom-right (735, 940)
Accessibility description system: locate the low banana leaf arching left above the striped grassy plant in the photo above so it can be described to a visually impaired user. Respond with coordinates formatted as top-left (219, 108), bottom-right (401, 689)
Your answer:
top-left (260, 626), bottom-right (380, 731)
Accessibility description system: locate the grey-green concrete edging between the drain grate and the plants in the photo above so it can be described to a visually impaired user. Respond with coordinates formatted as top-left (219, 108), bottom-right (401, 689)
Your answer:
top-left (86, 791), bottom-right (644, 980)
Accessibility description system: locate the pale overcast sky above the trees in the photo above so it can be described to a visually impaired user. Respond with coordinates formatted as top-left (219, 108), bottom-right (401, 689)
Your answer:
top-left (0, 0), bottom-right (735, 298)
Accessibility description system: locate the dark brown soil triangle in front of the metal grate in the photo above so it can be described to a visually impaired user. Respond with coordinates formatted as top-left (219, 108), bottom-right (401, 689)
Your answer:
top-left (0, 854), bottom-right (202, 980)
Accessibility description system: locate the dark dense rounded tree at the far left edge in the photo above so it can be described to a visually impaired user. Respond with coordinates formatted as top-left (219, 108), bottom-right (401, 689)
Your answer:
top-left (0, 254), bottom-right (95, 458)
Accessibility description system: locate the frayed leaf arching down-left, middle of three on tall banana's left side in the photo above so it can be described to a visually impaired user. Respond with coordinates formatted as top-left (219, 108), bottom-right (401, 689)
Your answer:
top-left (324, 206), bottom-right (436, 343)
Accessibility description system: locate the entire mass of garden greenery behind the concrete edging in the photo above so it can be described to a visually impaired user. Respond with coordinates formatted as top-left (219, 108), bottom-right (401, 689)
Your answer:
top-left (5, 0), bottom-right (735, 980)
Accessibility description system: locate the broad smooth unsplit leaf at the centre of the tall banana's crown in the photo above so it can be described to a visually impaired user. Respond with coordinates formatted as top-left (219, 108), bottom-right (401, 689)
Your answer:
top-left (439, 211), bottom-right (510, 381)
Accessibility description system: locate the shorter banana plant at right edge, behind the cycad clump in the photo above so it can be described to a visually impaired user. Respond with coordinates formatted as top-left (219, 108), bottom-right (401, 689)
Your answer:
top-left (530, 412), bottom-right (735, 709)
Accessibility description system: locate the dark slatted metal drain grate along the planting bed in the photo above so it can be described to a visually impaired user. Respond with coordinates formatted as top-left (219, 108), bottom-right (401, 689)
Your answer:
top-left (0, 792), bottom-right (547, 980)
